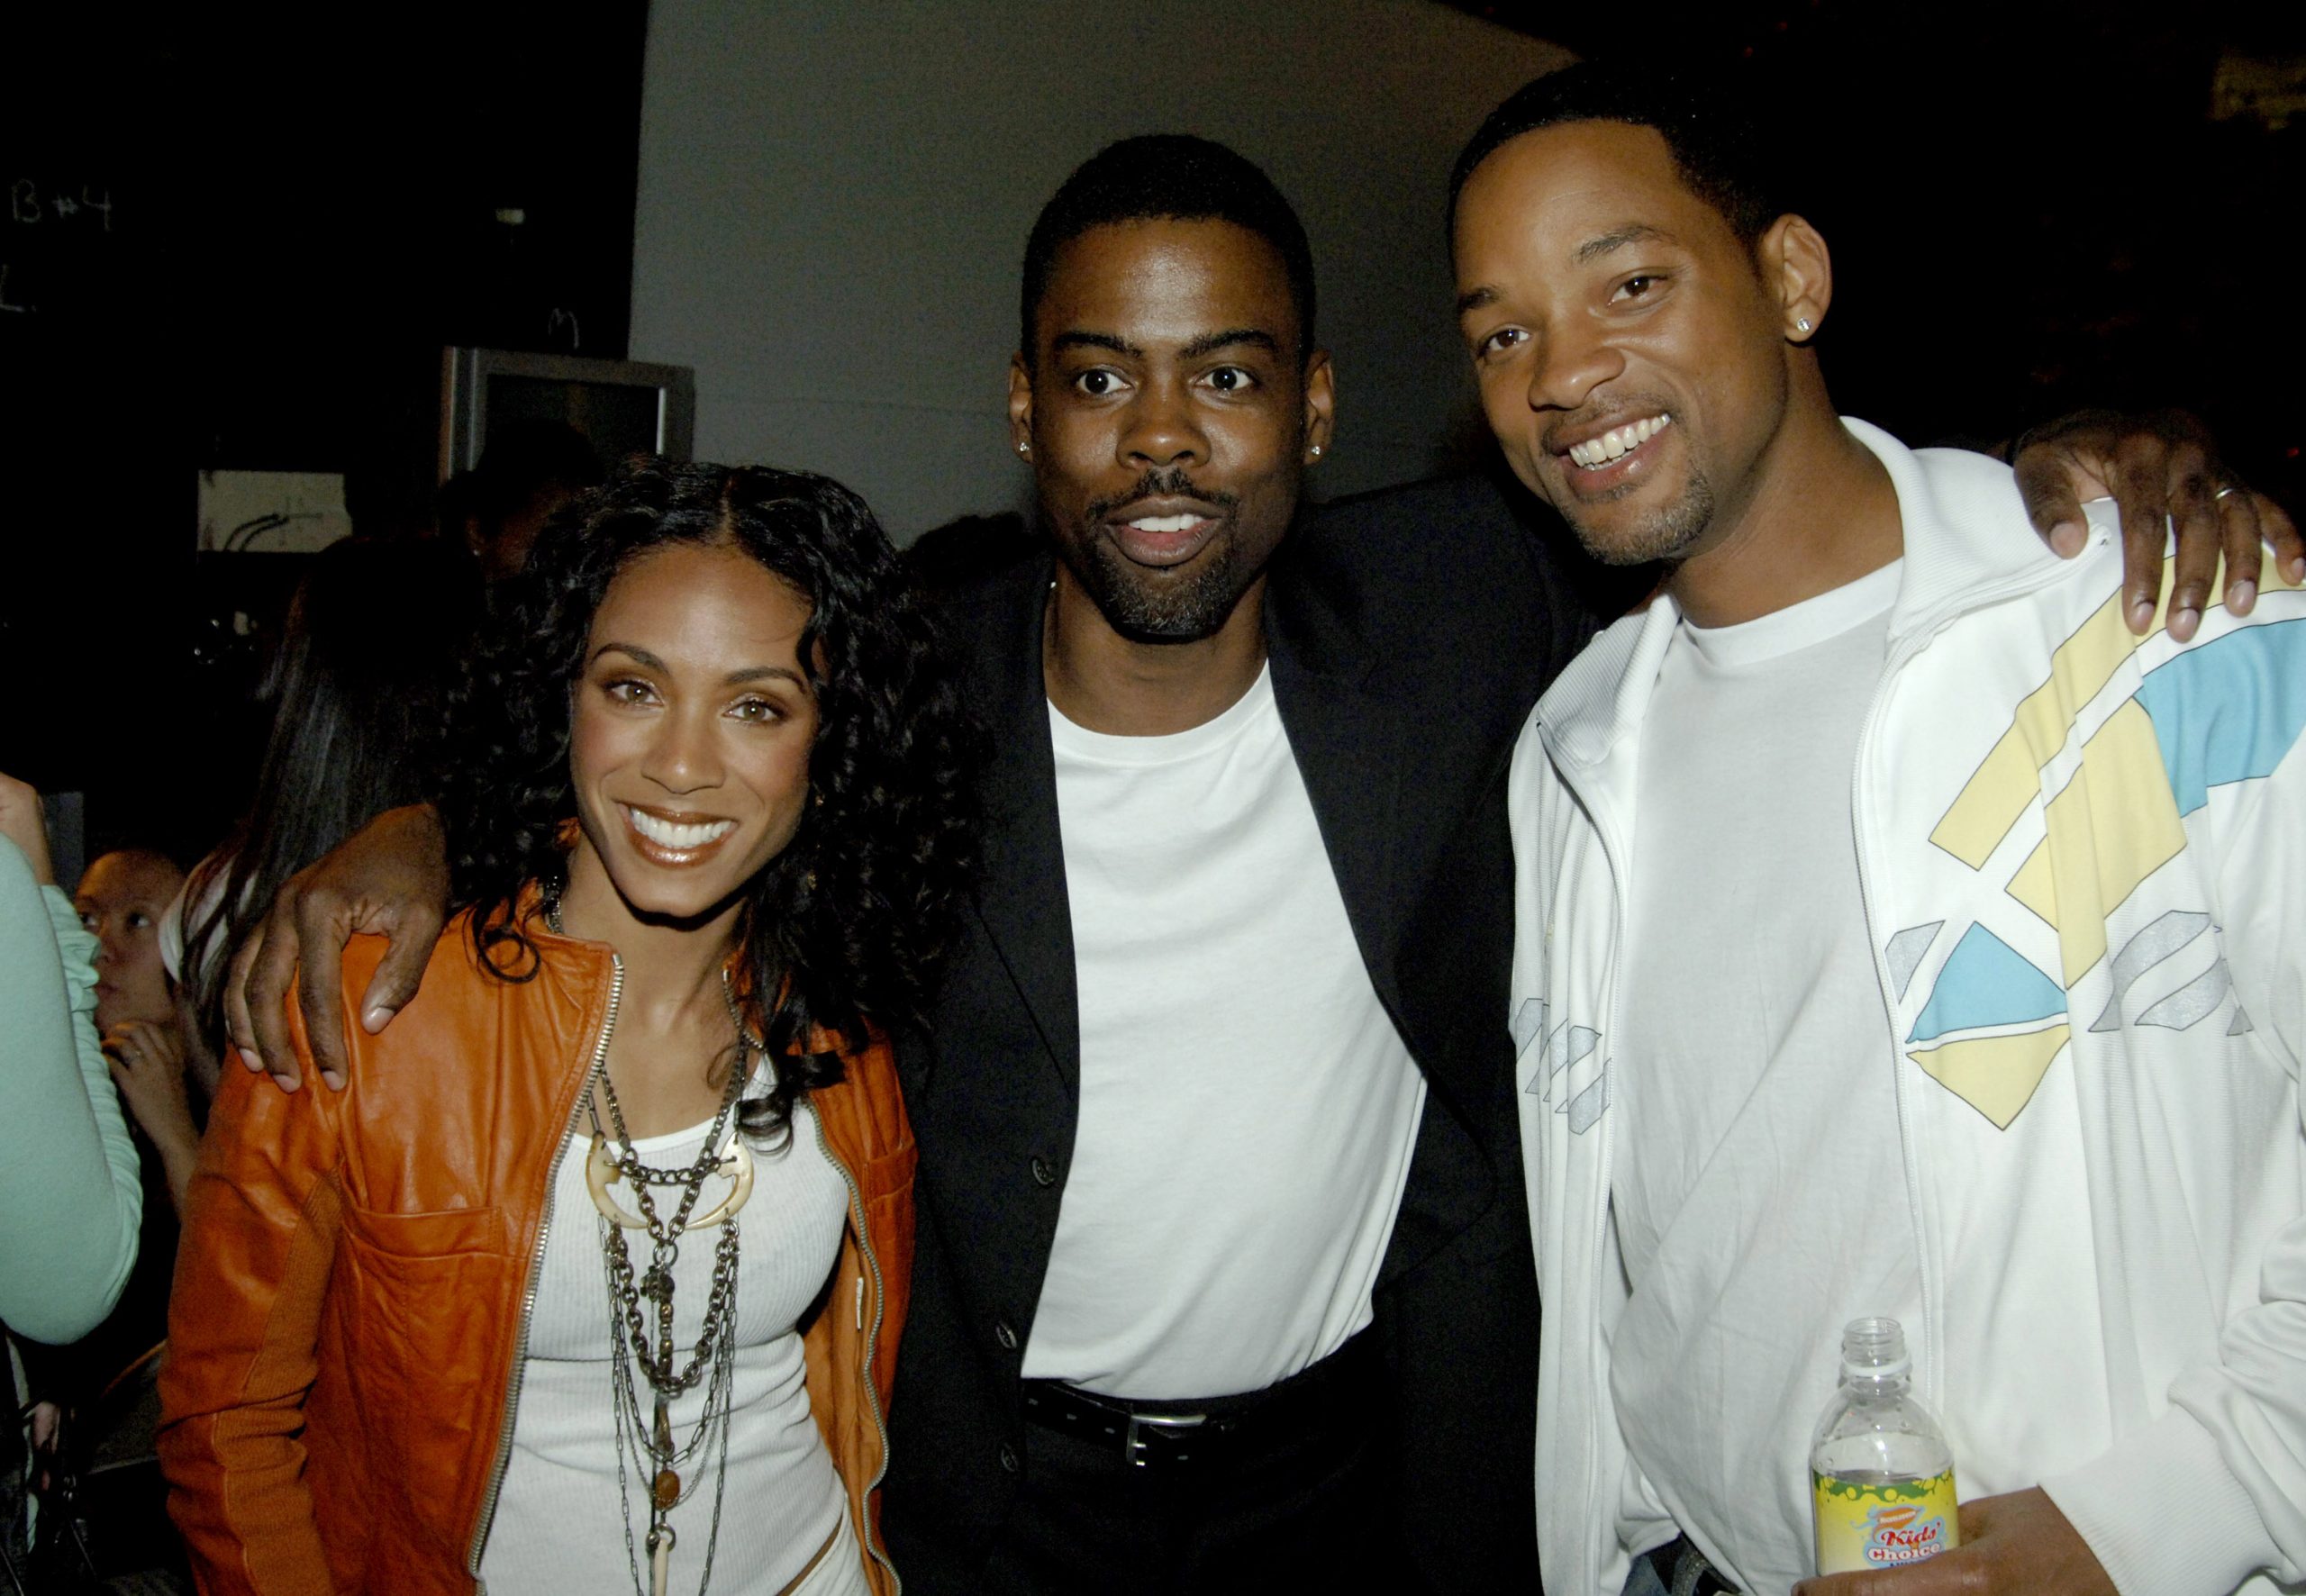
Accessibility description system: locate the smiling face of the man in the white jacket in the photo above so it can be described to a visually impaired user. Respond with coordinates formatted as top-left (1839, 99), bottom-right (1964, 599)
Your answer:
top-left (1453, 122), bottom-right (1790, 565)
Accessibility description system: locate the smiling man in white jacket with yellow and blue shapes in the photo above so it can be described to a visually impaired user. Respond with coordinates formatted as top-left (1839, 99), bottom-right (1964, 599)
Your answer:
top-left (1453, 67), bottom-right (2306, 1596)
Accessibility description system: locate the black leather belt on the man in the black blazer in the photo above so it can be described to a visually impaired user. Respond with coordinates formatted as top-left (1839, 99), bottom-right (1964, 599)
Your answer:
top-left (1024, 1336), bottom-right (1376, 1469)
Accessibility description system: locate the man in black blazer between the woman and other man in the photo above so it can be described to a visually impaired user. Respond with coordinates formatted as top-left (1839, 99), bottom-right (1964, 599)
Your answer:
top-left (883, 139), bottom-right (1593, 1591)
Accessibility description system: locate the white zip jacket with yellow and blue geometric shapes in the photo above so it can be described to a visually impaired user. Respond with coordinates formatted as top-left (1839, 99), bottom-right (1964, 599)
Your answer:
top-left (1511, 422), bottom-right (2306, 1596)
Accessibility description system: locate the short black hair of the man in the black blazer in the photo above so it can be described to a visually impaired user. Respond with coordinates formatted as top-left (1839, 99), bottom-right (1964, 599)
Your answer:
top-left (1017, 134), bottom-right (1314, 365)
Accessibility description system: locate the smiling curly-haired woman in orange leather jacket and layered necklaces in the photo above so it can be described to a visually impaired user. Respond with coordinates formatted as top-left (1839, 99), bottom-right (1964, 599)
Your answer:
top-left (161, 461), bottom-right (971, 1596)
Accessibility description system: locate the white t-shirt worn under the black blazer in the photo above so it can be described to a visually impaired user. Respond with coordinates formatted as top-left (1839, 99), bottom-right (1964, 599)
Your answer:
top-left (1024, 671), bottom-right (1425, 1398)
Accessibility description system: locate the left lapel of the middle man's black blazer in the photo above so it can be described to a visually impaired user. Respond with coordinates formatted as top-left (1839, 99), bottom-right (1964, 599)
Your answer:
top-left (973, 560), bottom-right (1082, 1093)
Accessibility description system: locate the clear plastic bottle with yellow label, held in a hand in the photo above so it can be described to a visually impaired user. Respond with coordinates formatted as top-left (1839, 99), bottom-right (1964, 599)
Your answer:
top-left (1811, 1319), bottom-right (1963, 1573)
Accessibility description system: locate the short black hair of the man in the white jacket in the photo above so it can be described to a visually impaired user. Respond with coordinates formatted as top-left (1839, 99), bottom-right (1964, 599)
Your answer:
top-left (1448, 60), bottom-right (1787, 244)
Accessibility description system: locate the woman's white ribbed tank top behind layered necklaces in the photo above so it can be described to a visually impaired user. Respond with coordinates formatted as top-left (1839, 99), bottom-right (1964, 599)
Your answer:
top-left (479, 1084), bottom-right (865, 1596)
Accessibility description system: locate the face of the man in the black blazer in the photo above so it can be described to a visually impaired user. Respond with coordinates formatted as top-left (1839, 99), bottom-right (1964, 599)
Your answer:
top-left (1010, 222), bottom-right (1330, 641)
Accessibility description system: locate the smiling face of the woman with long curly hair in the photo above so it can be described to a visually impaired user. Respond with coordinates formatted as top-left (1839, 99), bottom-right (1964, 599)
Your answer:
top-left (569, 544), bottom-right (816, 920)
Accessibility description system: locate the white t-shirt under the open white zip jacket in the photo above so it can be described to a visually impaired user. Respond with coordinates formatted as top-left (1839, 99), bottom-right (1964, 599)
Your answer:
top-left (1610, 565), bottom-right (1920, 1591)
